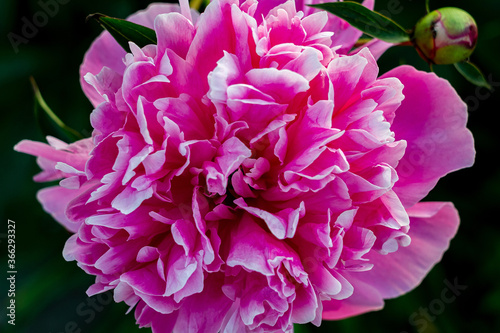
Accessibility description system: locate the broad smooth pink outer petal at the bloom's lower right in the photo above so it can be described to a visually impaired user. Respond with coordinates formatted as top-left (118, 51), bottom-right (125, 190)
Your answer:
top-left (323, 202), bottom-right (459, 319)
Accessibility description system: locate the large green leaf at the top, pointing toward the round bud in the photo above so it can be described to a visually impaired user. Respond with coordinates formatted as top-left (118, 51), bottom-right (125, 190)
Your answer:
top-left (310, 1), bottom-right (410, 44)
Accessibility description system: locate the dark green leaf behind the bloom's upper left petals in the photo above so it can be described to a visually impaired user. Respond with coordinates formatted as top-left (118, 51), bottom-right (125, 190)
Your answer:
top-left (87, 13), bottom-right (157, 52)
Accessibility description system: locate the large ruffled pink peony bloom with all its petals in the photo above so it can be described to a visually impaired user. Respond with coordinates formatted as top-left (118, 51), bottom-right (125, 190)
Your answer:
top-left (16, 0), bottom-right (474, 333)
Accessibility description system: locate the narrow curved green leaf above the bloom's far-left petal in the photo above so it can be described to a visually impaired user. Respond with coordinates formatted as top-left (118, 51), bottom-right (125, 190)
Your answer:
top-left (30, 77), bottom-right (83, 142)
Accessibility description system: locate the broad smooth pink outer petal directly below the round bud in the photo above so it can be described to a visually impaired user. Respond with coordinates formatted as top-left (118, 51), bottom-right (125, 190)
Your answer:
top-left (383, 66), bottom-right (475, 207)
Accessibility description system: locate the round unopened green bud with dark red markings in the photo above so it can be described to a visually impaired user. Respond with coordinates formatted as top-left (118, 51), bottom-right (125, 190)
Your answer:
top-left (412, 7), bottom-right (477, 65)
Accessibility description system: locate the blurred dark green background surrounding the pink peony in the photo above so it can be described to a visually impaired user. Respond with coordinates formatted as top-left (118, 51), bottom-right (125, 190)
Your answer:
top-left (0, 0), bottom-right (500, 333)
